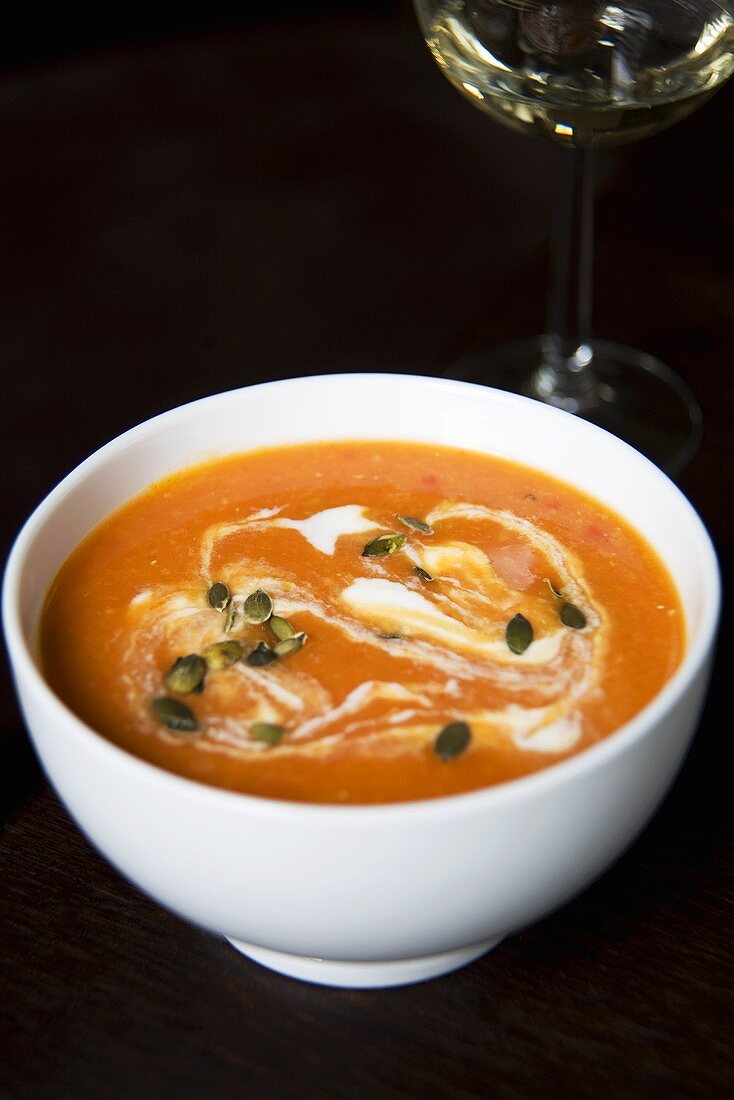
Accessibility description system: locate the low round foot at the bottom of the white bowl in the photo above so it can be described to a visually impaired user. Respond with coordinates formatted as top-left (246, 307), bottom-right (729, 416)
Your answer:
top-left (228, 936), bottom-right (503, 989)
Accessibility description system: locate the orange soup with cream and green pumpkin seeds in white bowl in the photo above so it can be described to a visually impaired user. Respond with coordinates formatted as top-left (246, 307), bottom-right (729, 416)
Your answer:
top-left (40, 441), bottom-right (684, 803)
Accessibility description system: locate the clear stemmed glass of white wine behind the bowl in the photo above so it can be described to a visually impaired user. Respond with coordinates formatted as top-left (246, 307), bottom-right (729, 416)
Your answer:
top-left (414, 0), bottom-right (734, 474)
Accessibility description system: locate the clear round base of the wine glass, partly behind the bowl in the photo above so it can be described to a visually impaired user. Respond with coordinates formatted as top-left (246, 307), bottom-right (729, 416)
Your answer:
top-left (442, 337), bottom-right (702, 476)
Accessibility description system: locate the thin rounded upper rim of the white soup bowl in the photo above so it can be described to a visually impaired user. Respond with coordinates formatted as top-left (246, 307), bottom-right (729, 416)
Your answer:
top-left (2, 372), bottom-right (721, 825)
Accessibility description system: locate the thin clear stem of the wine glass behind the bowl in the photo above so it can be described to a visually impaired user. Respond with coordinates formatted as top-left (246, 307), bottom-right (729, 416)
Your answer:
top-left (532, 146), bottom-right (598, 413)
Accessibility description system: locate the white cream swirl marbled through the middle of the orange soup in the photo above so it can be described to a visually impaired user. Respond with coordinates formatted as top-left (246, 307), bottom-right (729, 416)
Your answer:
top-left (122, 502), bottom-right (606, 759)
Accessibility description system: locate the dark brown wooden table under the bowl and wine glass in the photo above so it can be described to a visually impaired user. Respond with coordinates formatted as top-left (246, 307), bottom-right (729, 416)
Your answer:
top-left (0, 3), bottom-right (734, 1100)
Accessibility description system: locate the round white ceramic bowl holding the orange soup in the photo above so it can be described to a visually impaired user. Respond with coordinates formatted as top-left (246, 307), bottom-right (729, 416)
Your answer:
top-left (3, 374), bottom-right (720, 987)
